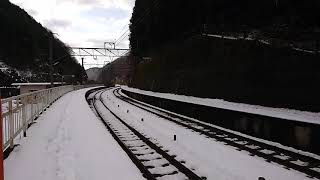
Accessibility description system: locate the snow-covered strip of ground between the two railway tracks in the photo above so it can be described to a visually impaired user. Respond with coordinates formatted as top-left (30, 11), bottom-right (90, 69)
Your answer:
top-left (103, 89), bottom-right (310, 180)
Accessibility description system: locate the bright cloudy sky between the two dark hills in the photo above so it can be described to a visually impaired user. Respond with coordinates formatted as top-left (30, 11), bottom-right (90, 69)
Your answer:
top-left (10, 0), bottom-right (135, 68)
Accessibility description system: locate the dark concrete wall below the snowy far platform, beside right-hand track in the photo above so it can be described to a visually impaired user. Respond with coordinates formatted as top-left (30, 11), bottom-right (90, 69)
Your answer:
top-left (122, 90), bottom-right (320, 154)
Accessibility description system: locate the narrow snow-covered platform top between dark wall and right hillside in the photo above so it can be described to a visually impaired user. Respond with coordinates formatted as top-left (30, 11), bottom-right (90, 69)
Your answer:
top-left (121, 86), bottom-right (320, 124)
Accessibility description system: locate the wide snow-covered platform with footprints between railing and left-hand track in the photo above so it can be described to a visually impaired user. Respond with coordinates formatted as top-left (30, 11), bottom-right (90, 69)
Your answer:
top-left (4, 89), bottom-right (144, 180)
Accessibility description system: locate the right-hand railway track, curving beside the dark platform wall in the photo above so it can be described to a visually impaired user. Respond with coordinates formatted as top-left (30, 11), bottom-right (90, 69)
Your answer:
top-left (113, 88), bottom-right (320, 179)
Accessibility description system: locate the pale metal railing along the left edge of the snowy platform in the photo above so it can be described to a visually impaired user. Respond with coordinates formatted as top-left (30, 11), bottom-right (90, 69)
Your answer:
top-left (1, 85), bottom-right (93, 151)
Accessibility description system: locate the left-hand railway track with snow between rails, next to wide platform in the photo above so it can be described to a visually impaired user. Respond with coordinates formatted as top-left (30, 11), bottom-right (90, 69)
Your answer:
top-left (89, 90), bottom-right (206, 180)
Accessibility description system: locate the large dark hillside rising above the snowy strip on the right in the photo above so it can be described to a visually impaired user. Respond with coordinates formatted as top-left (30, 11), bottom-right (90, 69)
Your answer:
top-left (130, 0), bottom-right (320, 111)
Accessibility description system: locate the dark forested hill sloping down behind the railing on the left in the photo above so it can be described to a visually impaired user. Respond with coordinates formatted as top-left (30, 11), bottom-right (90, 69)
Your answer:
top-left (0, 1), bottom-right (85, 86)
